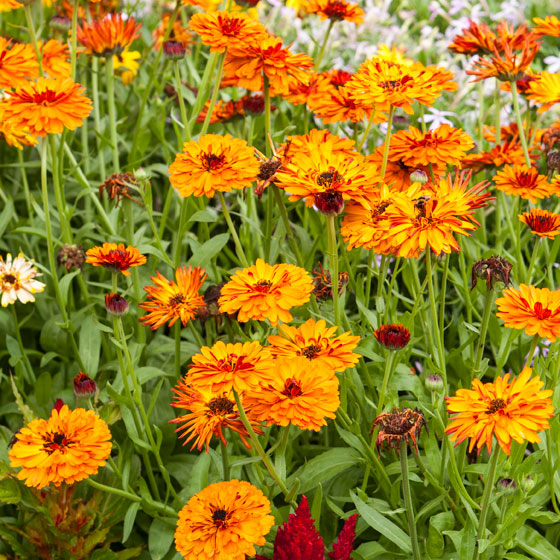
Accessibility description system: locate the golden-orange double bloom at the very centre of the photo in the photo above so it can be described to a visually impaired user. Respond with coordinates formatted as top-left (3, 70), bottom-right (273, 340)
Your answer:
top-left (218, 259), bottom-right (313, 326)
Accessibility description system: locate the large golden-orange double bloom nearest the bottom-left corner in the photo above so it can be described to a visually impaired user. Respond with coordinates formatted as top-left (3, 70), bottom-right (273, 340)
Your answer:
top-left (9, 405), bottom-right (111, 488)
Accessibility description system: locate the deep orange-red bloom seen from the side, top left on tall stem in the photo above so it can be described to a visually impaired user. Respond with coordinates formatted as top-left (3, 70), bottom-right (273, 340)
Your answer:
top-left (76, 14), bottom-right (142, 57)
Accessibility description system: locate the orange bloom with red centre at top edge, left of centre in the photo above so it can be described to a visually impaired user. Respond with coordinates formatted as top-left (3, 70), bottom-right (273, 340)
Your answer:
top-left (189, 11), bottom-right (268, 53)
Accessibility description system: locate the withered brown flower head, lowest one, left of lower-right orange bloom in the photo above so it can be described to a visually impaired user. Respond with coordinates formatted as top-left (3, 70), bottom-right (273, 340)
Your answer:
top-left (371, 408), bottom-right (428, 453)
